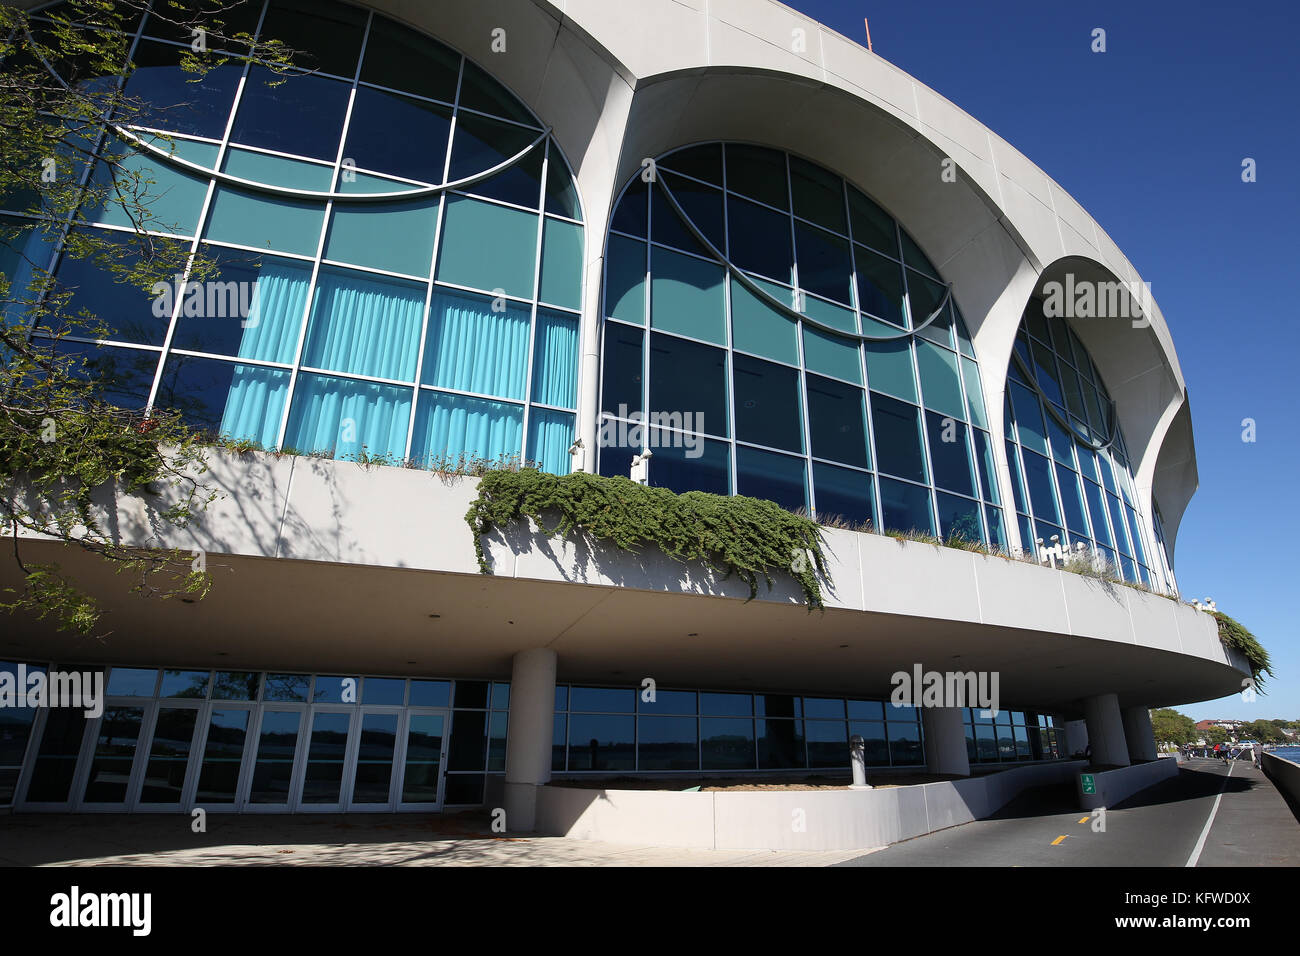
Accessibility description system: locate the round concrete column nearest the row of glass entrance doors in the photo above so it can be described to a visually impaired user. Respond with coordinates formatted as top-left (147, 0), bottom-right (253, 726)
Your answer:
top-left (506, 648), bottom-right (555, 832)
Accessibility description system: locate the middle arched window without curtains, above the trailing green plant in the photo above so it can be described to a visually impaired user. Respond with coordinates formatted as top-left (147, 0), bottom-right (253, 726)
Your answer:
top-left (598, 143), bottom-right (1004, 546)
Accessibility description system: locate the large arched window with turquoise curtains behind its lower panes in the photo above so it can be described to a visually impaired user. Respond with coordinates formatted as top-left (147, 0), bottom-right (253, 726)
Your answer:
top-left (11, 0), bottom-right (585, 472)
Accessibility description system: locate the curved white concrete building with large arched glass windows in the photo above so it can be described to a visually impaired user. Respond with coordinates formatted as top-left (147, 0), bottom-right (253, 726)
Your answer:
top-left (0, 0), bottom-right (1249, 830)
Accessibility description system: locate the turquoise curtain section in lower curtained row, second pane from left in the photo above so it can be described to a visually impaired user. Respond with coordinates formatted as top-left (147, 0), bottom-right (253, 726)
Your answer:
top-left (285, 372), bottom-right (411, 459)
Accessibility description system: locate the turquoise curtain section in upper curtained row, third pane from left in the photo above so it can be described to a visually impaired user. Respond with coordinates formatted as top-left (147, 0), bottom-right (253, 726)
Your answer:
top-left (420, 287), bottom-right (530, 400)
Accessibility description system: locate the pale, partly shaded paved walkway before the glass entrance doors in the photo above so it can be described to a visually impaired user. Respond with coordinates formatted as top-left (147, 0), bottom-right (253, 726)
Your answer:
top-left (0, 813), bottom-right (862, 866)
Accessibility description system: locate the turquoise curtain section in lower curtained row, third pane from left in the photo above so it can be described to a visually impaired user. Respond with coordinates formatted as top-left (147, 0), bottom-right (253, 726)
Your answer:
top-left (411, 390), bottom-right (522, 467)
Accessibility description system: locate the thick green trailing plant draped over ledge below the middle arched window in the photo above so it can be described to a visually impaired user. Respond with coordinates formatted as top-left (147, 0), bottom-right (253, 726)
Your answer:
top-left (465, 468), bottom-right (827, 611)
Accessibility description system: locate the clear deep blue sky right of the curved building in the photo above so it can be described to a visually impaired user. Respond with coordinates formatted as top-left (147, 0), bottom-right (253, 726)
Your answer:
top-left (785, 0), bottom-right (1300, 719)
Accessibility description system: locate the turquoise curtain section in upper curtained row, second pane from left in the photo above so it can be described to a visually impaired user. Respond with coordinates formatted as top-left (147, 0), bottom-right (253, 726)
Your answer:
top-left (303, 269), bottom-right (424, 382)
